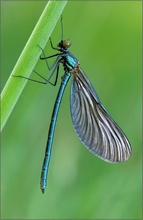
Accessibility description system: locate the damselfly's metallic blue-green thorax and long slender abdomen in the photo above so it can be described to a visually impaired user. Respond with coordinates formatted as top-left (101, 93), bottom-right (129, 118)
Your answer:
top-left (40, 46), bottom-right (78, 193)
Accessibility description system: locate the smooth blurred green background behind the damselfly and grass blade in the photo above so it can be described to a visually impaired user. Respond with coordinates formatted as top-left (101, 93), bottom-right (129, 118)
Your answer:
top-left (1, 1), bottom-right (142, 219)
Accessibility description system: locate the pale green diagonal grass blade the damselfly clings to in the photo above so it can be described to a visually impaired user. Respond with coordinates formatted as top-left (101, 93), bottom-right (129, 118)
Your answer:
top-left (1, 1), bottom-right (67, 130)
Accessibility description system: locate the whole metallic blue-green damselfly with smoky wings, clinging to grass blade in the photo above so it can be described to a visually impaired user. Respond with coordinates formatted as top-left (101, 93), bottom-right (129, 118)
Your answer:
top-left (13, 18), bottom-right (131, 193)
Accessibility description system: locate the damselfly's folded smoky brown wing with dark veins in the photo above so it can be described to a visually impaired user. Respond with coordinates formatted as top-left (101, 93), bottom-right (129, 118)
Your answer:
top-left (70, 66), bottom-right (131, 162)
